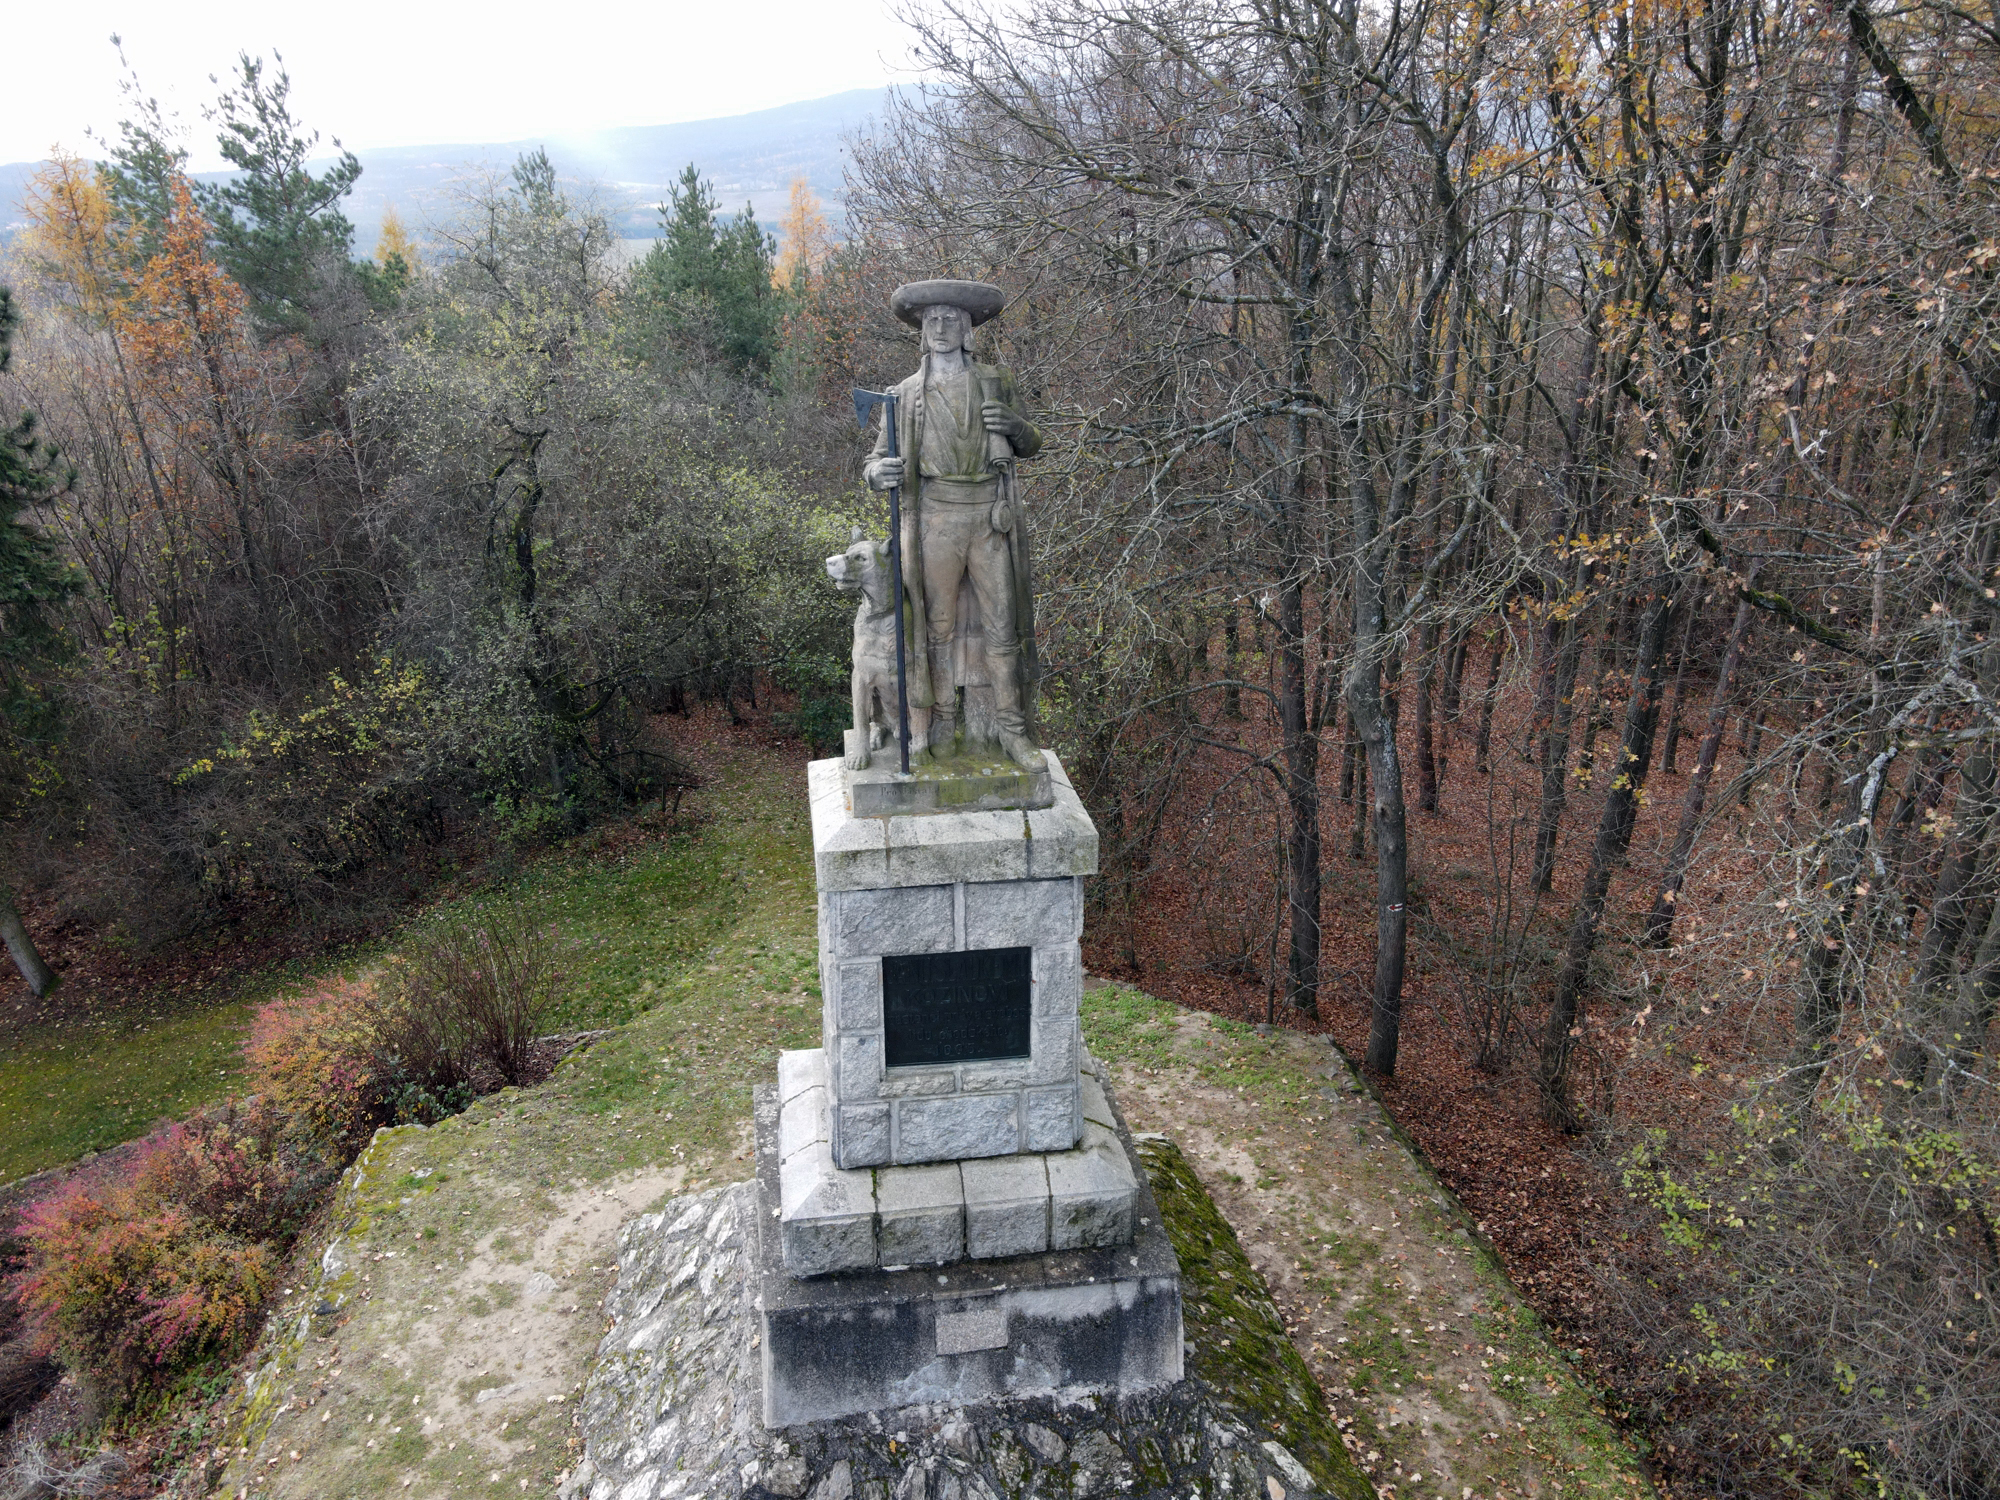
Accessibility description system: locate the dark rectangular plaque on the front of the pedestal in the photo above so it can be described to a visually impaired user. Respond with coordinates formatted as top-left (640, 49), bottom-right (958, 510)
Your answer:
top-left (882, 948), bottom-right (1034, 1068)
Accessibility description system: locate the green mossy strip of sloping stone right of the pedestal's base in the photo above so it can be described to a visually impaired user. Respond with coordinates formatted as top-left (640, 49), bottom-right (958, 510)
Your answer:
top-left (1138, 1136), bottom-right (1374, 1500)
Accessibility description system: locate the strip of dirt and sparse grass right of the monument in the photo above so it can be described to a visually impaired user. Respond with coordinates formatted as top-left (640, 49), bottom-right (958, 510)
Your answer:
top-left (1086, 984), bottom-right (1648, 1500)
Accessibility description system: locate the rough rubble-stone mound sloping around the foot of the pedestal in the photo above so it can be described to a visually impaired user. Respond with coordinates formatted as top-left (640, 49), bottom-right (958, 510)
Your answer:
top-left (562, 1136), bottom-right (1372, 1500)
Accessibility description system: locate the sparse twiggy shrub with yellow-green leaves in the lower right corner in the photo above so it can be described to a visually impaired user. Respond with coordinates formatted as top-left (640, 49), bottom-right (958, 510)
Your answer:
top-left (1610, 1088), bottom-right (2000, 1496)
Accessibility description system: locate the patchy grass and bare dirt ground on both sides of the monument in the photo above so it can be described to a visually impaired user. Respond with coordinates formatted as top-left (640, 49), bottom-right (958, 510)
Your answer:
top-left (172, 750), bottom-right (1640, 1500)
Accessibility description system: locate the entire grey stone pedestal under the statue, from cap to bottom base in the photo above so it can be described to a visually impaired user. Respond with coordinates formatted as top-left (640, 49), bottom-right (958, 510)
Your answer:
top-left (756, 754), bottom-right (1182, 1426)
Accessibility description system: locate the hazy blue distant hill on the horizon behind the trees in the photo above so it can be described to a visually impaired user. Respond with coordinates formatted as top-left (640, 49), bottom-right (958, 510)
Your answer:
top-left (0, 88), bottom-right (888, 254)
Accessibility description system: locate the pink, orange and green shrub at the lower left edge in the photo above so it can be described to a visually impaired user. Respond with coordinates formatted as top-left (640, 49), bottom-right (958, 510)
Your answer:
top-left (8, 1108), bottom-right (314, 1402)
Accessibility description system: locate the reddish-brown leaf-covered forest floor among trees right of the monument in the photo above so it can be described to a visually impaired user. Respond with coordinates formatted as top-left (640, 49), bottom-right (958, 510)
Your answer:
top-left (1084, 658), bottom-right (1782, 1456)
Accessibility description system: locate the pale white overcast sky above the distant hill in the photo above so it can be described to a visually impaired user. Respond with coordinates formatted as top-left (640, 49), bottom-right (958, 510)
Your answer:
top-left (0, 0), bottom-right (908, 170)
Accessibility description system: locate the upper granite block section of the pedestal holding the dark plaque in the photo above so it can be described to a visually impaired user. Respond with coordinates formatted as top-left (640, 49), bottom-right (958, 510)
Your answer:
top-left (808, 752), bottom-right (1098, 1172)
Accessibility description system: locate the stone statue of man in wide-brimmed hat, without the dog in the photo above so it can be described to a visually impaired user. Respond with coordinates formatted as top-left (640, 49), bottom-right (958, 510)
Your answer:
top-left (864, 280), bottom-right (1044, 770)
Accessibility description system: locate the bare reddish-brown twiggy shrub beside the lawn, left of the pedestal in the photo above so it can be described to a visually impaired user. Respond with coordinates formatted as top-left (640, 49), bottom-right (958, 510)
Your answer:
top-left (404, 902), bottom-right (566, 1084)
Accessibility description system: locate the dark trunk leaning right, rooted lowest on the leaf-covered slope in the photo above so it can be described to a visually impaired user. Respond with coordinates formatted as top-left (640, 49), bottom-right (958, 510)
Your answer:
top-left (1536, 592), bottom-right (1674, 1130)
